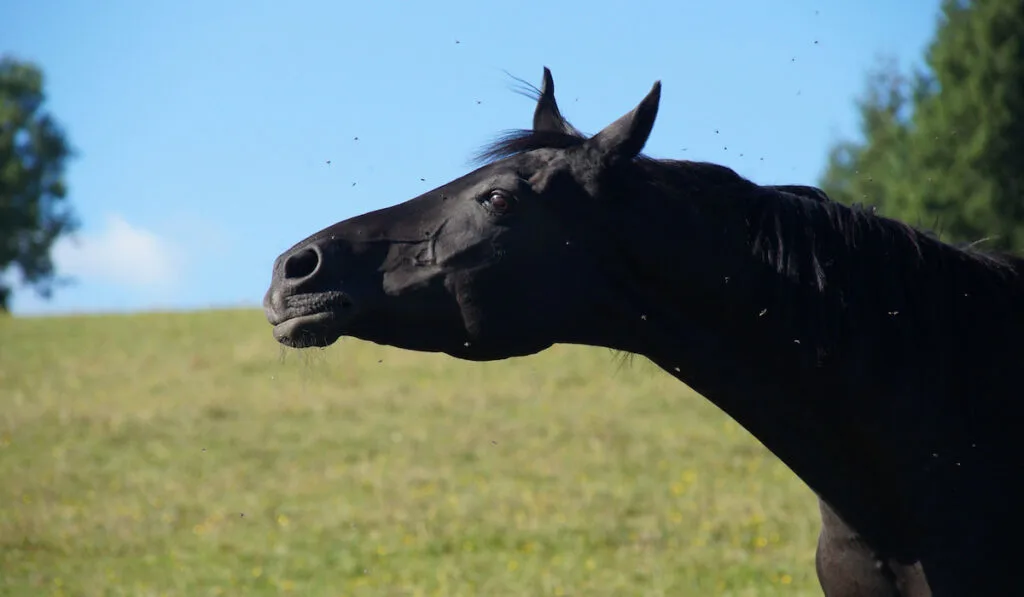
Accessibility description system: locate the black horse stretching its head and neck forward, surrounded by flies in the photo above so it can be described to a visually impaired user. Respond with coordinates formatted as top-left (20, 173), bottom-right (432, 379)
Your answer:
top-left (264, 69), bottom-right (1024, 596)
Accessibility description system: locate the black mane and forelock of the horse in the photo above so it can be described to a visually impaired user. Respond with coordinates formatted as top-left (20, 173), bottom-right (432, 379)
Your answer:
top-left (477, 129), bottom-right (1024, 370)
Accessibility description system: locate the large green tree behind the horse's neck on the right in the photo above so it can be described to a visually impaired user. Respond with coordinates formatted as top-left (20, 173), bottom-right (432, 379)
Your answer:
top-left (820, 0), bottom-right (1024, 251)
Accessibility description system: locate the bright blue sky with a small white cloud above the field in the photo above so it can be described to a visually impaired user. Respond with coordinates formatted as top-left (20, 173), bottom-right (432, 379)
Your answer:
top-left (0, 0), bottom-right (939, 314)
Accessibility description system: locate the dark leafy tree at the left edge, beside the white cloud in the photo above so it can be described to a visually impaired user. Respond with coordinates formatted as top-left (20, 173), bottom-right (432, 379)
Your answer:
top-left (0, 56), bottom-right (78, 312)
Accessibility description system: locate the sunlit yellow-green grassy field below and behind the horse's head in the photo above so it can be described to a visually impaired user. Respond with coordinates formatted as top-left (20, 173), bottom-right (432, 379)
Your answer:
top-left (0, 310), bottom-right (821, 597)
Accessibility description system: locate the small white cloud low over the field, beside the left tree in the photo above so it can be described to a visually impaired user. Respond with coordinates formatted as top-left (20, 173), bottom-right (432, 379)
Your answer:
top-left (52, 214), bottom-right (183, 289)
